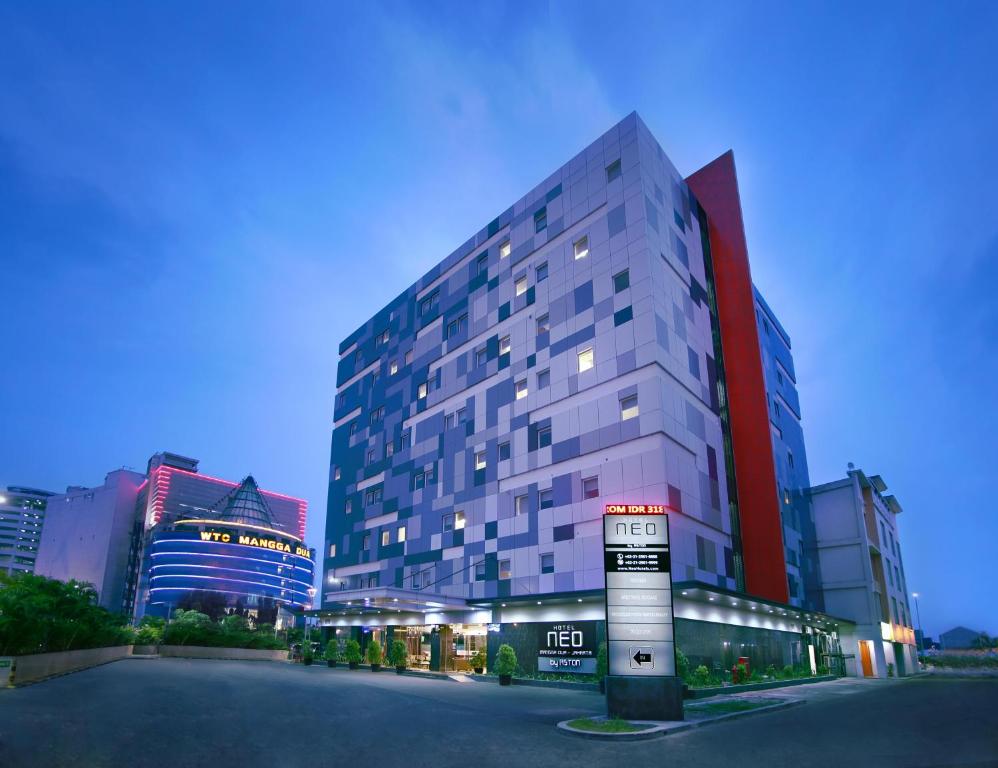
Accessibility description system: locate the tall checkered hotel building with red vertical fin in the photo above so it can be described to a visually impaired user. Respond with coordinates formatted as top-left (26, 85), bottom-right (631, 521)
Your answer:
top-left (316, 114), bottom-right (844, 671)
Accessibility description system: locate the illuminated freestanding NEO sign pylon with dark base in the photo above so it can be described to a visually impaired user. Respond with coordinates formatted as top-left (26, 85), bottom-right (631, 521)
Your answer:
top-left (603, 504), bottom-right (683, 720)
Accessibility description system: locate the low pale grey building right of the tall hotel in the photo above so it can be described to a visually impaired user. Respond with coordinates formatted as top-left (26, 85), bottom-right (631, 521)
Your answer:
top-left (810, 465), bottom-right (918, 677)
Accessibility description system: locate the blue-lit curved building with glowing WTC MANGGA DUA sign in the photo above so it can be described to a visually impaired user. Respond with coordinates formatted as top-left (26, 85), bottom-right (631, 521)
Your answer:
top-left (142, 476), bottom-right (315, 625)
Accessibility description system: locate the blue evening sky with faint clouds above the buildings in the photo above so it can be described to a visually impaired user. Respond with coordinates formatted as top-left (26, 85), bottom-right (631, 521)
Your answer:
top-left (0, 2), bottom-right (998, 634)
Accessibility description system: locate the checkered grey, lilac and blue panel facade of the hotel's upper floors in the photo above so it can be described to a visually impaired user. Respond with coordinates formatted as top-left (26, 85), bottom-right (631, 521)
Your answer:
top-left (322, 114), bottom-right (735, 602)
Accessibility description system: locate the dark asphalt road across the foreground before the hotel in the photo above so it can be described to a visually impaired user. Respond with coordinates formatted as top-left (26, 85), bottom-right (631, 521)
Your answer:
top-left (0, 659), bottom-right (998, 768)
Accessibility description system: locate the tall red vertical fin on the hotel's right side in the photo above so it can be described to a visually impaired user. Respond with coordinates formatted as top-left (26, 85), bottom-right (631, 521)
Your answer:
top-left (686, 150), bottom-right (789, 603)
